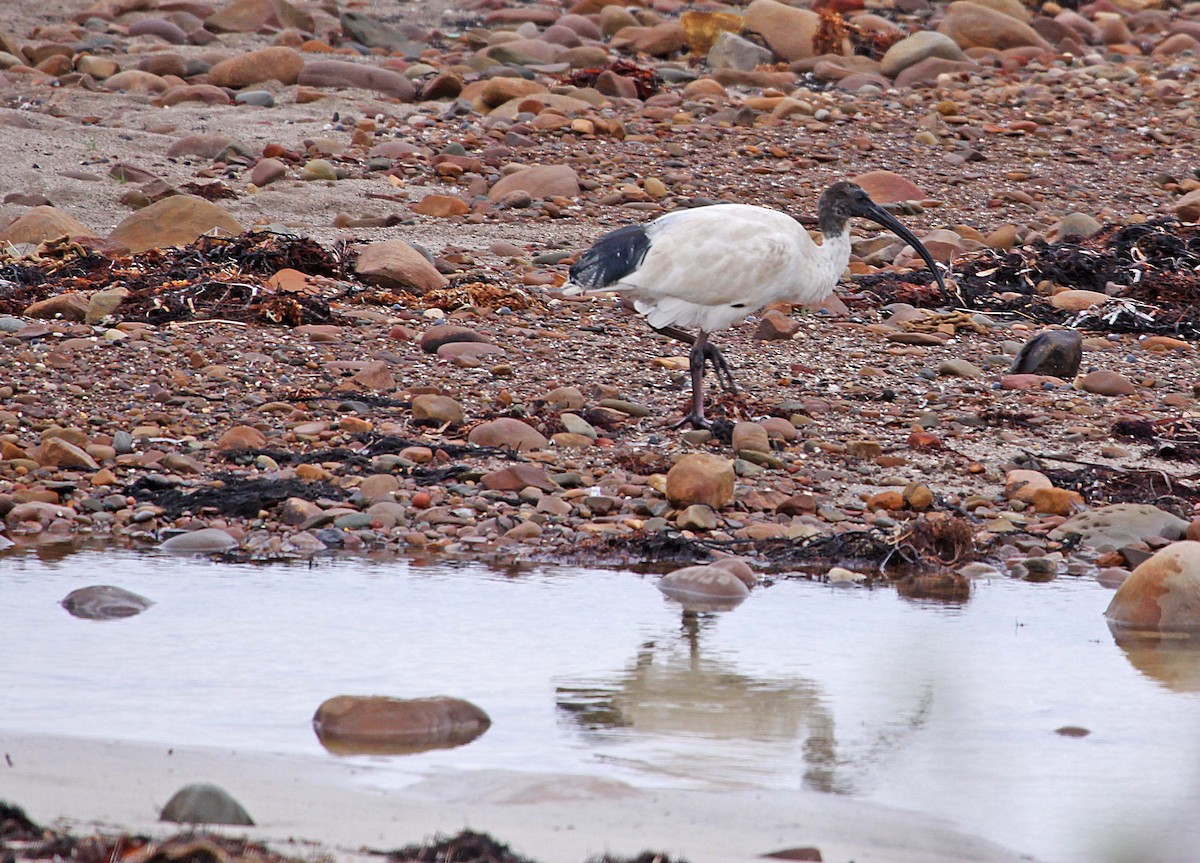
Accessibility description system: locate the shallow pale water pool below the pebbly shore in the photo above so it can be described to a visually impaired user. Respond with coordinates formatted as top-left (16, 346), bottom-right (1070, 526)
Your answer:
top-left (0, 550), bottom-right (1200, 863)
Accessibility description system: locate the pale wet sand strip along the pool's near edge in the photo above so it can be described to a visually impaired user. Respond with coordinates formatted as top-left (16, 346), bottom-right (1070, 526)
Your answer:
top-left (0, 735), bottom-right (1032, 863)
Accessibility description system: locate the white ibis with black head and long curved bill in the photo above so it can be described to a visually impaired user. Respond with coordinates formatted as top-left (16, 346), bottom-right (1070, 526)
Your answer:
top-left (563, 182), bottom-right (946, 428)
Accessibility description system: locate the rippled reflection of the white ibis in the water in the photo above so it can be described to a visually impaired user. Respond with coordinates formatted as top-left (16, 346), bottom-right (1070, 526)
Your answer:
top-left (557, 610), bottom-right (851, 792)
